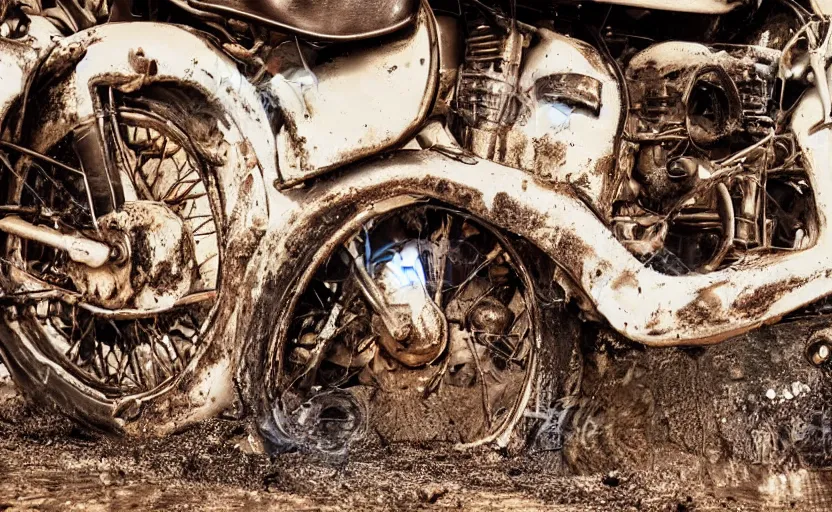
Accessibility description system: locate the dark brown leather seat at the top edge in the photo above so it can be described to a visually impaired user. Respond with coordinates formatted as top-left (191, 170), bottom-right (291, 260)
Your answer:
top-left (188, 0), bottom-right (419, 41)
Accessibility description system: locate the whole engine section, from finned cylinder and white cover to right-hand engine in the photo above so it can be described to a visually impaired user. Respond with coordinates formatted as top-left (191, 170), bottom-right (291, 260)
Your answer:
top-left (454, 2), bottom-right (817, 274)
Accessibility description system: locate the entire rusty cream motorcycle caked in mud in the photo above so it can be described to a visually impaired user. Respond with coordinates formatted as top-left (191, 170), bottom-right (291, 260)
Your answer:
top-left (0, 0), bottom-right (832, 452)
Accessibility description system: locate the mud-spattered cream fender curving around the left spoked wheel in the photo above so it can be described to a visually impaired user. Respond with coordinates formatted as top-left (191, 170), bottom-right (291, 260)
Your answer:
top-left (16, 23), bottom-right (281, 433)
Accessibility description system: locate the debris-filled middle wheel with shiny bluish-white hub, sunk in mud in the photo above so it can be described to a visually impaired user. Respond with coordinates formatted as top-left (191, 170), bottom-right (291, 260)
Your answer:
top-left (264, 205), bottom-right (538, 451)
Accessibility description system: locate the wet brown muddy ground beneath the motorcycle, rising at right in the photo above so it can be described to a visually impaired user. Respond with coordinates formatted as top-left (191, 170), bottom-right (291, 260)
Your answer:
top-left (0, 319), bottom-right (832, 511)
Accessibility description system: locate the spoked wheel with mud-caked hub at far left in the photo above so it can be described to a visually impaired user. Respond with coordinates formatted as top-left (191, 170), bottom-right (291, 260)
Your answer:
top-left (0, 89), bottom-right (222, 428)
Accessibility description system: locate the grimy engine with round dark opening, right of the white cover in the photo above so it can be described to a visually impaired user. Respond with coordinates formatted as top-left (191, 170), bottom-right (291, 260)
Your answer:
top-left (613, 42), bottom-right (813, 273)
